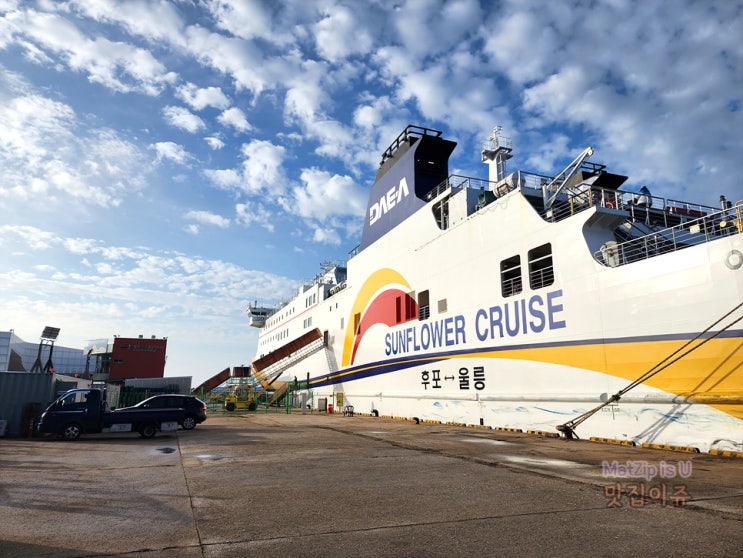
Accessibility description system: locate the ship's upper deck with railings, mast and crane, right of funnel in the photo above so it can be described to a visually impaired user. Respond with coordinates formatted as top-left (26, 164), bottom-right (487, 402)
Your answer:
top-left (384, 128), bottom-right (743, 267)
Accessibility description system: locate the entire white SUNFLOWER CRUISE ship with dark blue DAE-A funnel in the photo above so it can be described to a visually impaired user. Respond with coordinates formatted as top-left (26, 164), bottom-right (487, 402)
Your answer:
top-left (247, 126), bottom-right (743, 451)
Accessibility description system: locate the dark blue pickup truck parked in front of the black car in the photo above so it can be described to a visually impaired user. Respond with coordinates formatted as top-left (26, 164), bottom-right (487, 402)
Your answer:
top-left (38, 388), bottom-right (185, 440)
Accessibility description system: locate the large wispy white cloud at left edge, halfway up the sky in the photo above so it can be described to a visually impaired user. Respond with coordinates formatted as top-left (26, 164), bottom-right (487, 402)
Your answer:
top-left (0, 82), bottom-right (148, 213)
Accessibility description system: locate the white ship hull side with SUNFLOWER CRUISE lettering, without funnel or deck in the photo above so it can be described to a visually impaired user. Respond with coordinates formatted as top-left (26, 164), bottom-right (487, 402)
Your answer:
top-left (251, 127), bottom-right (743, 451)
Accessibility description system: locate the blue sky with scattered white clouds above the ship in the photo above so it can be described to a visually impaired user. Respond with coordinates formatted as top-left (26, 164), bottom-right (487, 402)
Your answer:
top-left (0, 0), bottom-right (743, 385)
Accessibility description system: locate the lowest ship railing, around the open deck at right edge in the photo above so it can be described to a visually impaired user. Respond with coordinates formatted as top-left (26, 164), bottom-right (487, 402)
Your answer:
top-left (594, 200), bottom-right (743, 267)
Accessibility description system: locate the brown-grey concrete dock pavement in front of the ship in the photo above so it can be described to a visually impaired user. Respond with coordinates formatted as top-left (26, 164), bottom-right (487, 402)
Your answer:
top-left (0, 413), bottom-right (743, 558)
